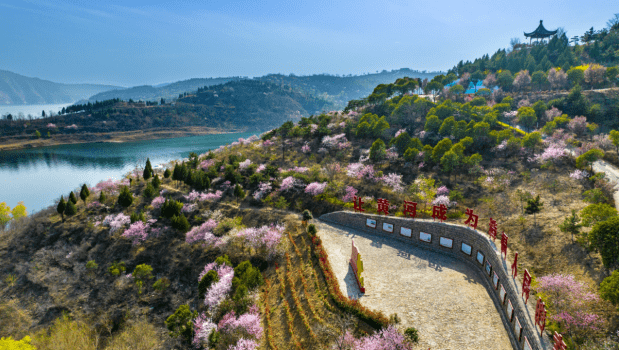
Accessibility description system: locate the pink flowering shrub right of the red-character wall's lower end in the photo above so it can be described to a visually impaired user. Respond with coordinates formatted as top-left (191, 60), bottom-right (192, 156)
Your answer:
top-left (535, 274), bottom-right (605, 340)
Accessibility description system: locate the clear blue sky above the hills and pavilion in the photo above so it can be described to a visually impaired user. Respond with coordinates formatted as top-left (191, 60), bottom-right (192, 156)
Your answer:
top-left (0, 0), bottom-right (619, 86)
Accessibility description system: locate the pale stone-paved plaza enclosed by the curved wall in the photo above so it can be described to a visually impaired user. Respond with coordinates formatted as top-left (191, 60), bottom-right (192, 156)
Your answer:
top-left (316, 220), bottom-right (512, 350)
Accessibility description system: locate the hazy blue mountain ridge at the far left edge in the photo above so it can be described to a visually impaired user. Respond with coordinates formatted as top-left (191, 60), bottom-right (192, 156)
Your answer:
top-left (0, 70), bottom-right (123, 105)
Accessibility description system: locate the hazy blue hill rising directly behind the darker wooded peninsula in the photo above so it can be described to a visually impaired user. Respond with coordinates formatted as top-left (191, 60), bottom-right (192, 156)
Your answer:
top-left (88, 77), bottom-right (244, 102)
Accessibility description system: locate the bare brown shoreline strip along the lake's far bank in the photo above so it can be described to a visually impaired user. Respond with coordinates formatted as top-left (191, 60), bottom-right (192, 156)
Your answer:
top-left (0, 127), bottom-right (243, 151)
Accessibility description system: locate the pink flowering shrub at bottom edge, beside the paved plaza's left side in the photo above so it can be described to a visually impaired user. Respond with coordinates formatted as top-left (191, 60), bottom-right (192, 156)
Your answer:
top-left (342, 325), bottom-right (411, 350)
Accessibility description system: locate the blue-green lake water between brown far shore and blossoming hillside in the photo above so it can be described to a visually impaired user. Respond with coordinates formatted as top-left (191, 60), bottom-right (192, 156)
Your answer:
top-left (0, 133), bottom-right (256, 213)
